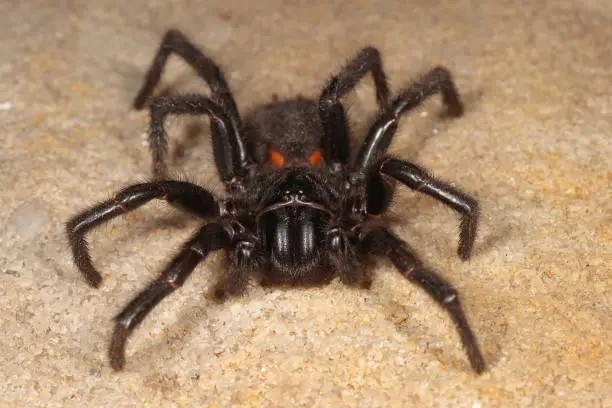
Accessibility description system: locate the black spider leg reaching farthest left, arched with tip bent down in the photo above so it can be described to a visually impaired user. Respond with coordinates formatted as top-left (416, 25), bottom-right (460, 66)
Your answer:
top-left (66, 181), bottom-right (219, 287)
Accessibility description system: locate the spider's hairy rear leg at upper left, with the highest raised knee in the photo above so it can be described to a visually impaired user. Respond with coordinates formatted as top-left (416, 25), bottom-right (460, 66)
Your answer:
top-left (134, 30), bottom-right (240, 119)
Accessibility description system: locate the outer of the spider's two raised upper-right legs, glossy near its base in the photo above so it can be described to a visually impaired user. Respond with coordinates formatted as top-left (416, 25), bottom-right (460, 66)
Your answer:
top-left (355, 67), bottom-right (463, 173)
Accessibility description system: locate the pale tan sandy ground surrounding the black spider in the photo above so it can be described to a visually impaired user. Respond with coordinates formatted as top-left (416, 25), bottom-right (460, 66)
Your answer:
top-left (0, 0), bottom-right (612, 408)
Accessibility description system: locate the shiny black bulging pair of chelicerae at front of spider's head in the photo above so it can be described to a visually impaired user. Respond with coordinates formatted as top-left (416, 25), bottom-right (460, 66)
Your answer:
top-left (260, 206), bottom-right (328, 281)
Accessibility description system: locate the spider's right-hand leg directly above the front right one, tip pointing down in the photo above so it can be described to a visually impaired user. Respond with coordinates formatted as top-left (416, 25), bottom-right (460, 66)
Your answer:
top-left (380, 158), bottom-right (478, 260)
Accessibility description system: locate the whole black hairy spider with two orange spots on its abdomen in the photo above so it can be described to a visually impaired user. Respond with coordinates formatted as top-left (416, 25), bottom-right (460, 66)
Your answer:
top-left (66, 30), bottom-right (485, 373)
